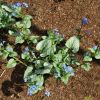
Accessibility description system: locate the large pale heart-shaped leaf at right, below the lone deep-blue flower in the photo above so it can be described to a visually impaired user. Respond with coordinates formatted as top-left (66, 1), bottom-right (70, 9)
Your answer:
top-left (65, 36), bottom-right (80, 53)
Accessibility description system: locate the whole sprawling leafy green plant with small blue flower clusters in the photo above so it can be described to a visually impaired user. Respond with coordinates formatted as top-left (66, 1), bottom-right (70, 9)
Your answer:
top-left (0, 2), bottom-right (100, 95)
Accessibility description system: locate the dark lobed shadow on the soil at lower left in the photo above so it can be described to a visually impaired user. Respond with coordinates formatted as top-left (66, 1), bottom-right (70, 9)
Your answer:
top-left (1, 65), bottom-right (26, 98)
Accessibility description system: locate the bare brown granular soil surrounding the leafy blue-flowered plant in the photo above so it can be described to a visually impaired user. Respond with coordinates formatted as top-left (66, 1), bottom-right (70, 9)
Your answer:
top-left (0, 0), bottom-right (100, 100)
